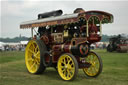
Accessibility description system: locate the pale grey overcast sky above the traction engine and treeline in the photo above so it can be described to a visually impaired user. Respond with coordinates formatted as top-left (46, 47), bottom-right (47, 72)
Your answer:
top-left (0, 0), bottom-right (128, 38)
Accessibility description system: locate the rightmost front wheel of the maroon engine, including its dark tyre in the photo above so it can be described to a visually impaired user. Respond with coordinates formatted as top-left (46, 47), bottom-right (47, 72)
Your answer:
top-left (83, 52), bottom-right (103, 77)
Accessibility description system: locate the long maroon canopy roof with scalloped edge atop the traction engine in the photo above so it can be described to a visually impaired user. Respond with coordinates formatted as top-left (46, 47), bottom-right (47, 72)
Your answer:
top-left (20, 11), bottom-right (113, 28)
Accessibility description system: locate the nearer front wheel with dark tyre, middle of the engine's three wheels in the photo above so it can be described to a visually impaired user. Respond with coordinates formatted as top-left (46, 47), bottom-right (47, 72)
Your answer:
top-left (57, 53), bottom-right (78, 81)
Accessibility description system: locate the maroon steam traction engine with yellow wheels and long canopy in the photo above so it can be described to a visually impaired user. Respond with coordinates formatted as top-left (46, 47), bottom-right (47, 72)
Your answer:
top-left (20, 8), bottom-right (113, 80)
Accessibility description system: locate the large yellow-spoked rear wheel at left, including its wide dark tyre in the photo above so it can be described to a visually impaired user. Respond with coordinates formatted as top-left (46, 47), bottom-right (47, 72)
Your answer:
top-left (25, 40), bottom-right (45, 74)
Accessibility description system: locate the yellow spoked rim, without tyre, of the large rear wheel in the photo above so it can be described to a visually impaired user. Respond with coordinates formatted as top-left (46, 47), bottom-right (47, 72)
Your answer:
top-left (25, 40), bottom-right (40, 73)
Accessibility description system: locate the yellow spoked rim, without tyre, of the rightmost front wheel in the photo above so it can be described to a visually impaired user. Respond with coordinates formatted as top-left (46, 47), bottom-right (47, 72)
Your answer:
top-left (83, 52), bottom-right (100, 77)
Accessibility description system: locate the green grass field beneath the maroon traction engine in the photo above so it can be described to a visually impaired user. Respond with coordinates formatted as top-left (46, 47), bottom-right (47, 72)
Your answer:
top-left (0, 50), bottom-right (128, 85)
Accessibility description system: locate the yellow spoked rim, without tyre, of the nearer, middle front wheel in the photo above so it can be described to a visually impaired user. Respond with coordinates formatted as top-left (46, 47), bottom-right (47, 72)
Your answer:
top-left (58, 54), bottom-right (75, 80)
